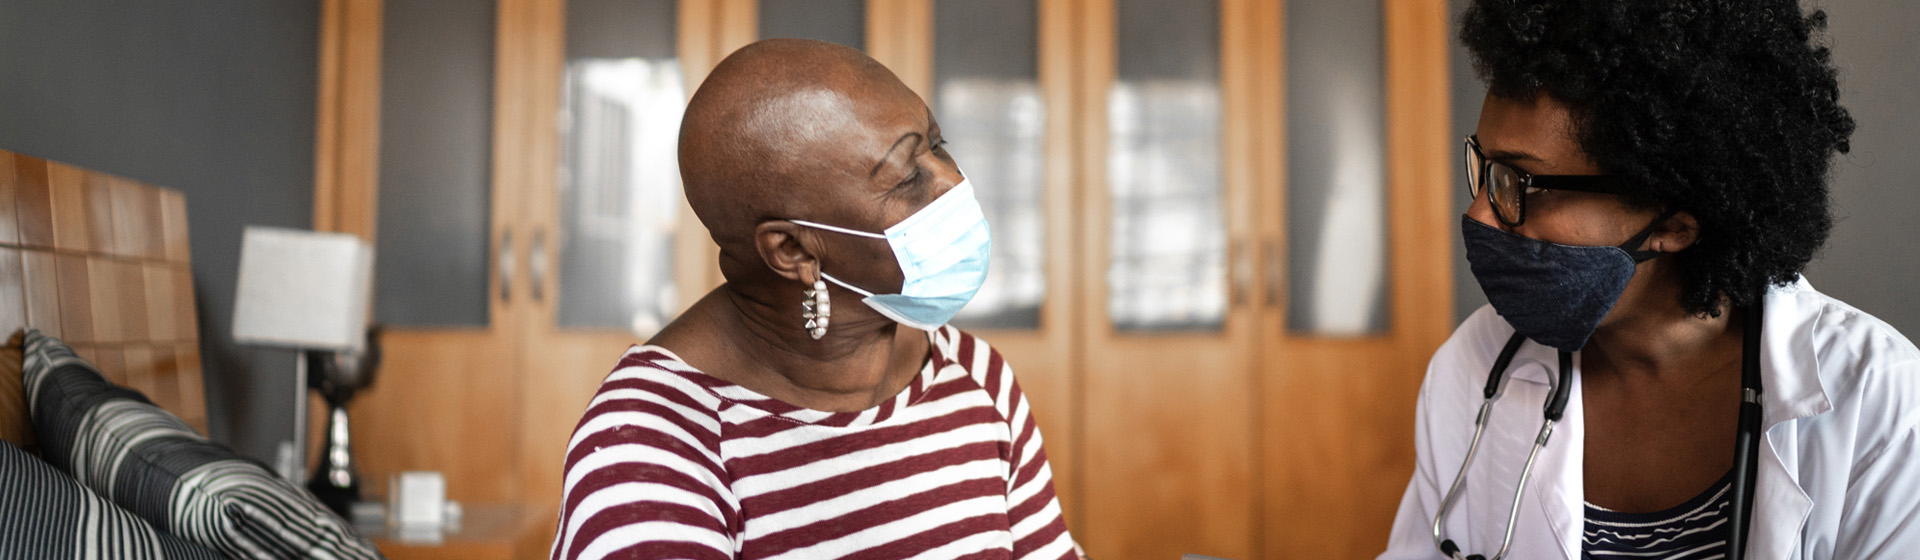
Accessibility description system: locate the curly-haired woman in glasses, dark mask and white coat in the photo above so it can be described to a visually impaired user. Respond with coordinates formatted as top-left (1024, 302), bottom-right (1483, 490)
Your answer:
top-left (1380, 0), bottom-right (1920, 560)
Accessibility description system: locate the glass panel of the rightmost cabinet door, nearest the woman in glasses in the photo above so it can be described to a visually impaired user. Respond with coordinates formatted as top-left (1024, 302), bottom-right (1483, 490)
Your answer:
top-left (1284, 0), bottom-right (1390, 336)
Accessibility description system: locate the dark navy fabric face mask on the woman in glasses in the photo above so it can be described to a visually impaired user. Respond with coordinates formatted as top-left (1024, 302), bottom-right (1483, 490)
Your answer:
top-left (1459, 211), bottom-right (1672, 353)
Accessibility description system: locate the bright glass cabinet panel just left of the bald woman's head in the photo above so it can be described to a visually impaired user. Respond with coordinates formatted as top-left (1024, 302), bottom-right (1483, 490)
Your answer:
top-left (557, 0), bottom-right (687, 336)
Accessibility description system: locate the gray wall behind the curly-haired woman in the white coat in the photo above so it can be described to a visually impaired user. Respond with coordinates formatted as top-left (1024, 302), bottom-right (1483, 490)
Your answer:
top-left (1450, 0), bottom-right (1920, 338)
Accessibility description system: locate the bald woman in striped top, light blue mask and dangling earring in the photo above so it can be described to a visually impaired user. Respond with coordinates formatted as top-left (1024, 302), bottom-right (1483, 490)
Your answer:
top-left (553, 40), bottom-right (1075, 560)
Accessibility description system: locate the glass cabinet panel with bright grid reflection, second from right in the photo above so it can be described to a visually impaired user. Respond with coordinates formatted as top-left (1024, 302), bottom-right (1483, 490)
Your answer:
top-left (1106, 0), bottom-right (1227, 330)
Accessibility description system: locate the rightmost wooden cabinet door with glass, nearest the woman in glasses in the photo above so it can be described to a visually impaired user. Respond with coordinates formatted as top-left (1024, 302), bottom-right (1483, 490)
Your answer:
top-left (1248, 0), bottom-right (1457, 558)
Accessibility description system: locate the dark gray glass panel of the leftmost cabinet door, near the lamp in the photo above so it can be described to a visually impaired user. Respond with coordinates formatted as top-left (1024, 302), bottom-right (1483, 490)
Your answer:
top-left (374, 0), bottom-right (495, 326)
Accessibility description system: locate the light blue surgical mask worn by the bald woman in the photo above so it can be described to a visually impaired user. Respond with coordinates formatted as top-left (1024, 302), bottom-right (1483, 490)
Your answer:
top-left (791, 178), bottom-right (991, 330)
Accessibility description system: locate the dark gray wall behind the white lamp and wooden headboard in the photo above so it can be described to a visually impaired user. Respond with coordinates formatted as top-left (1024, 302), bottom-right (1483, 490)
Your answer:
top-left (0, 0), bottom-right (319, 464)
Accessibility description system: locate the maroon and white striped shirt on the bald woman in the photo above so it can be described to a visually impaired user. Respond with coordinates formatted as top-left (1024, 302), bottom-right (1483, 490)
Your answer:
top-left (551, 326), bottom-right (1075, 560)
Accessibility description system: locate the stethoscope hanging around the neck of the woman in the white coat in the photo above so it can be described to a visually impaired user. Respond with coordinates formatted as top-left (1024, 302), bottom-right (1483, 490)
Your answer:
top-left (1434, 301), bottom-right (1764, 560)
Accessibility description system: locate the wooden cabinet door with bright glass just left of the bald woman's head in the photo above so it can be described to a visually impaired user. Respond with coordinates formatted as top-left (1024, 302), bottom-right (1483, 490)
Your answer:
top-left (503, 0), bottom-right (743, 521)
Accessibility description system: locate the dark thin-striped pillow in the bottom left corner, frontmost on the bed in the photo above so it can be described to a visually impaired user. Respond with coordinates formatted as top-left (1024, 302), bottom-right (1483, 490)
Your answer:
top-left (0, 441), bottom-right (225, 560)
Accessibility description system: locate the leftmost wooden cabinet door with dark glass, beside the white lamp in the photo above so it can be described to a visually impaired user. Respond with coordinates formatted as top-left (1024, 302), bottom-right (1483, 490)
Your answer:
top-left (309, 0), bottom-right (526, 502)
